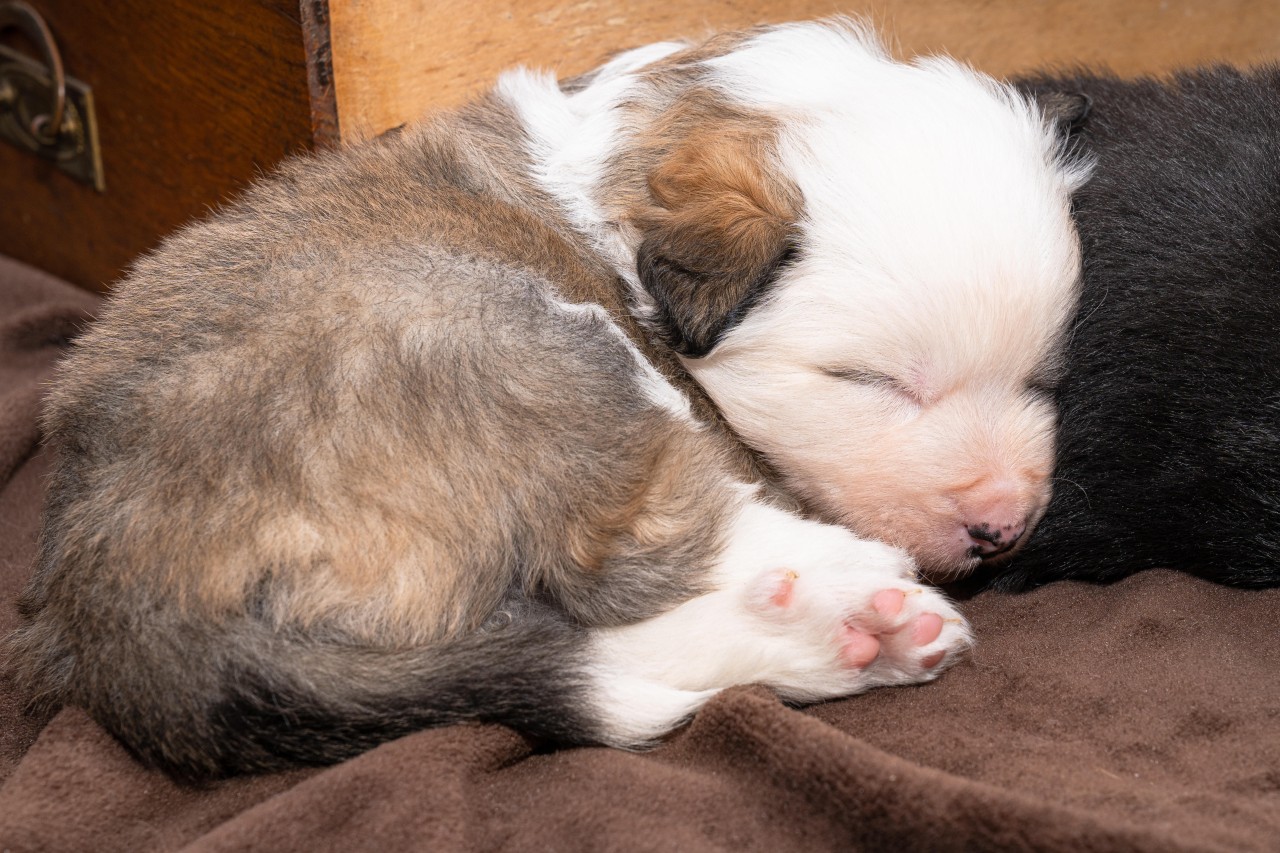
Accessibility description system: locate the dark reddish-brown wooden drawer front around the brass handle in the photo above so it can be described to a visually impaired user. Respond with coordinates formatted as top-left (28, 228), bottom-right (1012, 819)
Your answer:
top-left (0, 0), bottom-right (320, 289)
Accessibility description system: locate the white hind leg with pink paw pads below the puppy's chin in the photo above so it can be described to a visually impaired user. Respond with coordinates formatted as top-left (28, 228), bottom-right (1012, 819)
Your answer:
top-left (591, 498), bottom-right (972, 743)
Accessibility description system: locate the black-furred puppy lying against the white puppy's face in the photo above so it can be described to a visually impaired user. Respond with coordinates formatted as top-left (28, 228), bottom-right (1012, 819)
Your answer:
top-left (995, 68), bottom-right (1280, 589)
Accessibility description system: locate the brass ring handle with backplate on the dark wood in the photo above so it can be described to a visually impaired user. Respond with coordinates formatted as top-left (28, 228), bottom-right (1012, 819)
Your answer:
top-left (0, 0), bottom-right (105, 192)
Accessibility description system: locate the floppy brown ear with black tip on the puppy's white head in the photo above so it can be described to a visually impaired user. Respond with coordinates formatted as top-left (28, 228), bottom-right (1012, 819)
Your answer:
top-left (636, 128), bottom-right (799, 357)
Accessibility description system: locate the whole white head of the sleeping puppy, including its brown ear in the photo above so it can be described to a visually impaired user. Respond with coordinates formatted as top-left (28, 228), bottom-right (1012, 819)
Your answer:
top-left (500, 22), bottom-right (1087, 578)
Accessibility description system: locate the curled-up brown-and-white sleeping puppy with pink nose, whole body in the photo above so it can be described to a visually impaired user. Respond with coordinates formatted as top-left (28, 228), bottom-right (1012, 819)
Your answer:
top-left (7, 22), bottom-right (1083, 776)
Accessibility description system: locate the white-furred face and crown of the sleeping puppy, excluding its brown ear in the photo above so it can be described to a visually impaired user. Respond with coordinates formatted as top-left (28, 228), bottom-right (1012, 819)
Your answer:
top-left (686, 26), bottom-right (1085, 578)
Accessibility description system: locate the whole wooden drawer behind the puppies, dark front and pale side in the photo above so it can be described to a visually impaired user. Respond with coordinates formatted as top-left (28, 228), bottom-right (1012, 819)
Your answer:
top-left (0, 0), bottom-right (1280, 289)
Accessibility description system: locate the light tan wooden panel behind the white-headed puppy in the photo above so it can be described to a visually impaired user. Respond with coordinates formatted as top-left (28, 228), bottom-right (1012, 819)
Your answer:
top-left (329, 0), bottom-right (1280, 142)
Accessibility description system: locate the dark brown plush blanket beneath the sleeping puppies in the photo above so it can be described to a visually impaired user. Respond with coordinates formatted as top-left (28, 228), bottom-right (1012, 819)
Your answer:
top-left (0, 253), bottom-right (1280, 852)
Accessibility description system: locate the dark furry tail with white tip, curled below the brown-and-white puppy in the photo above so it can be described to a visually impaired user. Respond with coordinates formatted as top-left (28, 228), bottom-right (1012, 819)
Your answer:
top-left (18, 596), bottom-right (704, 779)
